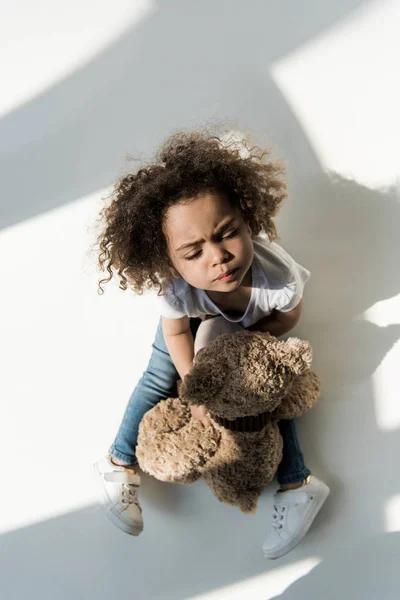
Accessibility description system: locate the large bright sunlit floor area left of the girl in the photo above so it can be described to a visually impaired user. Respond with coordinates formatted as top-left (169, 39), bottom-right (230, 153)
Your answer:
top-left (0, 190), bottom-right (158, 533)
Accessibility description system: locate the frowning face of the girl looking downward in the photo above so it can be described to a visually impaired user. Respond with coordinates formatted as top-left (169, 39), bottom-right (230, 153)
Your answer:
top-left (164, 191), bottom-right (254, 292)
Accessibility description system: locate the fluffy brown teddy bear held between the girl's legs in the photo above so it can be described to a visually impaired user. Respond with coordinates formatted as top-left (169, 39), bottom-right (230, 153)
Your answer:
top-left (137, 322), bottom-right (320, 513)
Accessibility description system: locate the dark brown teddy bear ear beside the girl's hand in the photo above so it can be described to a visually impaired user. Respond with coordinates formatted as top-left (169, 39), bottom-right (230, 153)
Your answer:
top-left (179, 358), bottom-right (226, 404)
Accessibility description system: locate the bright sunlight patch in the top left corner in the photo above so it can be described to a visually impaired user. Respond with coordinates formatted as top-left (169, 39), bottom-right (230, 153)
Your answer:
top-left (0, 0), bottom-right (154, 116)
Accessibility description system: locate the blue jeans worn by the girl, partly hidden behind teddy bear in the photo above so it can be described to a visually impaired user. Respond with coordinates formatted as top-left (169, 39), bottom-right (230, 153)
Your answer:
top-left (109, 319), bottom-right (310, 484)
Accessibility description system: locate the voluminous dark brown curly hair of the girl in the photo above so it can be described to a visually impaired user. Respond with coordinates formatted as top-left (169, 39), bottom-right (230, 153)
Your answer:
top-left (97, 130), bottom-right (286, 295)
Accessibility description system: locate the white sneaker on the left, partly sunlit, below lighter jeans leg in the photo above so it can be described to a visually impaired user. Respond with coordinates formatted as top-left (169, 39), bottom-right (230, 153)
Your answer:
top-left (93, 455), bottom-right (143, 535)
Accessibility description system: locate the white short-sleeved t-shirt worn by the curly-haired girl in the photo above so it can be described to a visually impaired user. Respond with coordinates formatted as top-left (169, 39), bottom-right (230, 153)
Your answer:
top-left (158, 234), bottom-right (310, 327)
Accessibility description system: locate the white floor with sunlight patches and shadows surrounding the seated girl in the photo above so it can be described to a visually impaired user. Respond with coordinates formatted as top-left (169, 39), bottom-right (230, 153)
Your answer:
top-left (0, 0), bottom-right (400, 600)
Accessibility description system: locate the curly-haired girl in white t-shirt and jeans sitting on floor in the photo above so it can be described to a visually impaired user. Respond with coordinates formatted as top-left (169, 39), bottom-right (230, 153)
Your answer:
top-left (94, 127), bottom-right (329, 558)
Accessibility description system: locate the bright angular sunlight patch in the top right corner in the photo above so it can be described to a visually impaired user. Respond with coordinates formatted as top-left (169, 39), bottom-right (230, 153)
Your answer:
top-left (272, 0), bottom-right (400, 187)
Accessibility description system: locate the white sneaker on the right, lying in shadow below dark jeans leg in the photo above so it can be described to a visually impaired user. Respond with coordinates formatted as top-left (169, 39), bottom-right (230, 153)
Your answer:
top-left (263, 475), bottom-right (330, 558)
